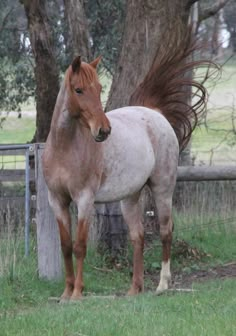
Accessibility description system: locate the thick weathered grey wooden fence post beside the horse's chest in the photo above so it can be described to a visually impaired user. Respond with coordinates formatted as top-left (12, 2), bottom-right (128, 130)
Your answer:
top-left (35, 144), bottom-right (62, 280)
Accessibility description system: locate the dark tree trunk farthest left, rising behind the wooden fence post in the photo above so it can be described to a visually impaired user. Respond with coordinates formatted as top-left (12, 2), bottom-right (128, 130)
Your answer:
top-left (21, 0), bottom-right (59, 142)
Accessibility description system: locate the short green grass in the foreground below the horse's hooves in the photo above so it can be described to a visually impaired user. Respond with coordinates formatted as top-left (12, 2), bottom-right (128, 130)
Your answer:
top-left (1, 280), bottom-right (236, 336)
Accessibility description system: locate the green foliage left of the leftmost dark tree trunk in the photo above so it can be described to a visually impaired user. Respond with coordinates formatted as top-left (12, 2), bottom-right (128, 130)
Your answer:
top-left (0, 0), bottom-right (35, 111)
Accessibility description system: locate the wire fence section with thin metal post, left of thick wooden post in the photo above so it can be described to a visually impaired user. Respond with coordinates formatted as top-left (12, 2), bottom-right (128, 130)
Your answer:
top-left (0, 145), bottom-right (34, 255)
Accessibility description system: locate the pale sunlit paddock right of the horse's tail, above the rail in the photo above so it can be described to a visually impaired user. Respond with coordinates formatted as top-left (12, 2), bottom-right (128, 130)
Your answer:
top-left (192, 60), bottom-right (236, 164)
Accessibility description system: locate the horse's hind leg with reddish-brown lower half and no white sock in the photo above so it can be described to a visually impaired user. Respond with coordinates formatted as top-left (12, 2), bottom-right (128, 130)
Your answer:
top-left (121, 193), bottom-right (144, 295)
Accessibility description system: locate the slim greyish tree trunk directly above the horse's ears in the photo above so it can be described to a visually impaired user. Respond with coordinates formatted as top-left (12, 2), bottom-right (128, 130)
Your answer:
top-left (64, 0), bottom-right (92, 62)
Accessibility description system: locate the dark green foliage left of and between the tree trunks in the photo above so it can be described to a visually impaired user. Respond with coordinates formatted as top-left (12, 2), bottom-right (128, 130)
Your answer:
top-left (0, 0), bottom-right (125, 111)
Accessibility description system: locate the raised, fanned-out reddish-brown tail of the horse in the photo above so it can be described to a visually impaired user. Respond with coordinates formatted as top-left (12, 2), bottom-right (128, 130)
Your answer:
top-left (129, 28), bottom-right (218, 149)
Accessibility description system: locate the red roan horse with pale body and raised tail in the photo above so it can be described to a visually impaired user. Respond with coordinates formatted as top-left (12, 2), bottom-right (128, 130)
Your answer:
top-left (43, 30), bottom-right (208, 300)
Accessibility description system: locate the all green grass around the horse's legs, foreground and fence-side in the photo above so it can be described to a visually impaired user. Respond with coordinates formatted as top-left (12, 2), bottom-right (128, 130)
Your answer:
top-left (0, 213), bottom-right (236, 336)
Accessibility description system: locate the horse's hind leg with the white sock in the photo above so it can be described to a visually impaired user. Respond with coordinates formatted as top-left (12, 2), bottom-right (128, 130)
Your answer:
top-left (151, 178), bottom-right (175, 293)
